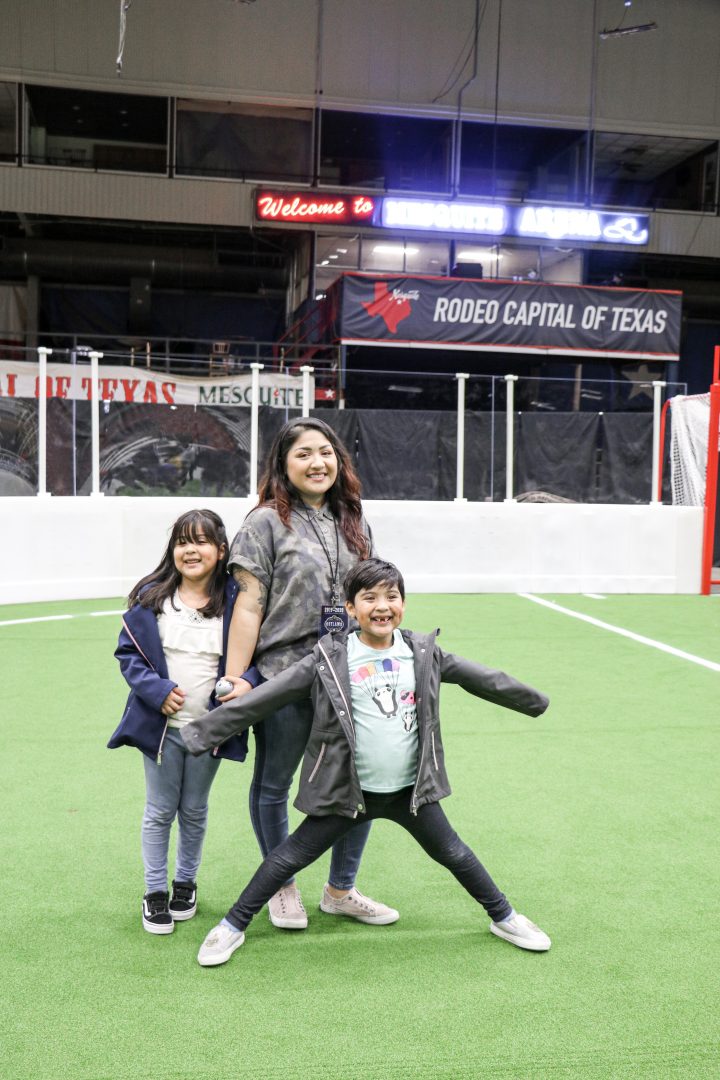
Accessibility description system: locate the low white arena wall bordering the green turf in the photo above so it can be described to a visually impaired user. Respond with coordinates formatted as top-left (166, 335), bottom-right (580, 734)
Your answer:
top-left (0, 496), bottom-right (703, 604)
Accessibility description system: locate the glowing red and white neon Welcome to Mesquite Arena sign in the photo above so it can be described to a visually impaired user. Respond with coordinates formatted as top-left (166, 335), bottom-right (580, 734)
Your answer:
top-left (255, 190), bottom-right (650, 244)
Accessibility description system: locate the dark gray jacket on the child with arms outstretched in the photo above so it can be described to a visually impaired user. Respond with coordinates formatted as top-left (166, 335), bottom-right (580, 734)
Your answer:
top-left (180, 630), bottom-right (548, 818)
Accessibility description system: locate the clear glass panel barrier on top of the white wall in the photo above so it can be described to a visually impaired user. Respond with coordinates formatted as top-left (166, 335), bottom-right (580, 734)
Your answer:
top-left (0, 350), bottom-right (685, 503)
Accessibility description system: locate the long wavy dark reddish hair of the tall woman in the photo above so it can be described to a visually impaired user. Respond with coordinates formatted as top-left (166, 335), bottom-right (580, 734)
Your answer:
top-left (256, 417), bottom-right (370, 558)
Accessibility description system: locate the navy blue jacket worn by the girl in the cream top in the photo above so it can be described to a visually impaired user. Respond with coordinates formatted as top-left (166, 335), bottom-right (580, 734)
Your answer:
top-left (108, 577), bottom-right (262, 761)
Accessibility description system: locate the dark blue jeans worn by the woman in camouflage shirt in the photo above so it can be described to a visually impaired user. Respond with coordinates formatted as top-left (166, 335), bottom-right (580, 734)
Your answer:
top-left (250, 699), bottom-right (370, 889)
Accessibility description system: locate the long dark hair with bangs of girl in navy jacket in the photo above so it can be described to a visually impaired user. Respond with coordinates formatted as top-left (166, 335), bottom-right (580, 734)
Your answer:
top-left (127, 510), bottom-right (229, 619)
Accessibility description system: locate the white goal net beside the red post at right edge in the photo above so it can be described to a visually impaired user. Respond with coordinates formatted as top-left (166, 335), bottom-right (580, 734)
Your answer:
top-left (670, 393), bottom-right (710, 507)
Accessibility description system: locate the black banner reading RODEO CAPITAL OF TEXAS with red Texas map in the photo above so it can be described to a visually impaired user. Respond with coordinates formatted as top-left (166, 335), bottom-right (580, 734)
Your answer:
top-left (337, 274), bottom-right (682, 361)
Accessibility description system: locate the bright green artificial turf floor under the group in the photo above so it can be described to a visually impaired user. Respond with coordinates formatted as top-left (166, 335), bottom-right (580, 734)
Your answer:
top-left (0, 595), bottom-right (720, 1080)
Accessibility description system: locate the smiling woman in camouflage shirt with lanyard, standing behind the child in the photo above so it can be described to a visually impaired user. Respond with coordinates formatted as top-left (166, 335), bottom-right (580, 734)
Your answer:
top-left (221, 417), bottom-right (399, 930)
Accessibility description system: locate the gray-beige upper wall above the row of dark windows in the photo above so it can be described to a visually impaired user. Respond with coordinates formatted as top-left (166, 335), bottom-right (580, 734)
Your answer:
top-left (0, 0), bottom-right (720, 138)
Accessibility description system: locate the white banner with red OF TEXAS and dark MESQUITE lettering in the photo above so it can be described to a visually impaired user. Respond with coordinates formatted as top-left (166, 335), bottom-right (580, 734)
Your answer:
top-left (0, 360), bottom-right (314, 408)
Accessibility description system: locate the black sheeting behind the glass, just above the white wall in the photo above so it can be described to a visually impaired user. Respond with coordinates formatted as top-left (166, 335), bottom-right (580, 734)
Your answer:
top-left (0, 400), bottom-right (669, 503)
